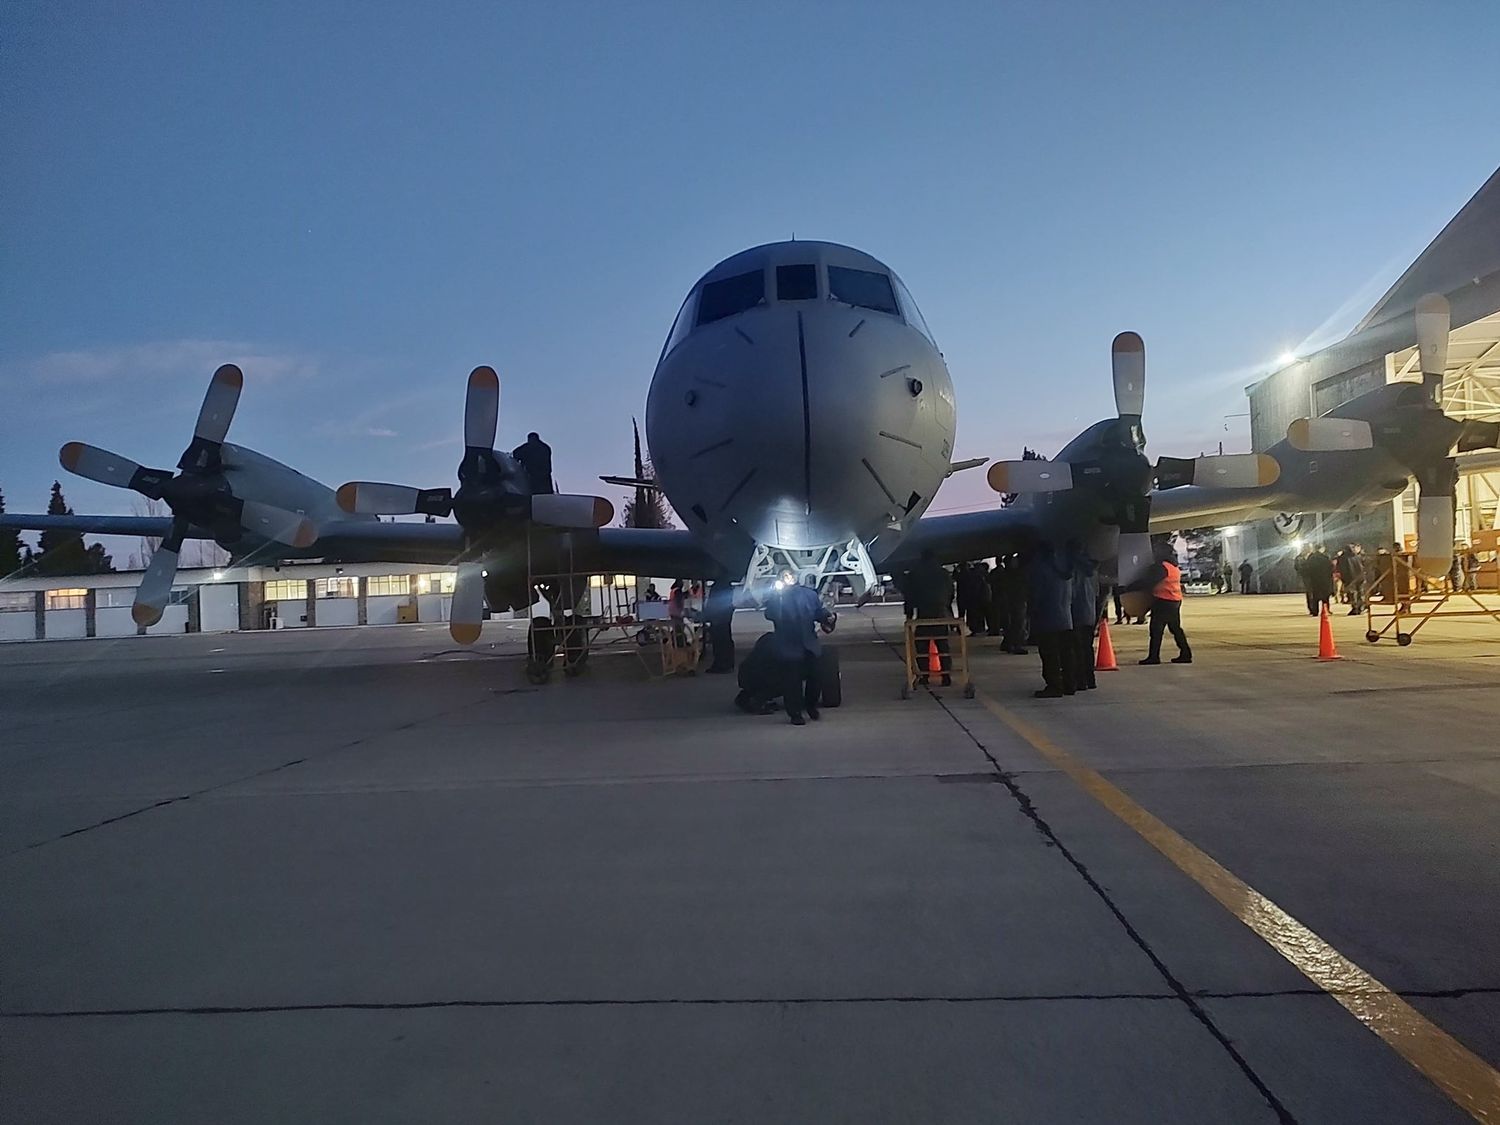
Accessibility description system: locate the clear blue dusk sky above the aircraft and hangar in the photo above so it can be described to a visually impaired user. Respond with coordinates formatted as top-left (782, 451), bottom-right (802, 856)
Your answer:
top-left (0, 0), bottom-right (1500, 534)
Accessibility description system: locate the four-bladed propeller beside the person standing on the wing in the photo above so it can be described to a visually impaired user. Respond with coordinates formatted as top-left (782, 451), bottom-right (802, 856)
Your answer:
top-left (338, 366), bottom-right (615, 645)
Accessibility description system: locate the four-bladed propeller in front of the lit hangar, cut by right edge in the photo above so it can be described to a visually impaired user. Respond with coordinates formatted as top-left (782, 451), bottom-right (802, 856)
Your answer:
top-left (1287, 293), bottom-right (1500, 575)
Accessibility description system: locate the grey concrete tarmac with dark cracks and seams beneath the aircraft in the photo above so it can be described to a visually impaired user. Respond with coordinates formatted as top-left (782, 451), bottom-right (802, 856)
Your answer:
top-left (0, 596), bottom-right (1500, 1124)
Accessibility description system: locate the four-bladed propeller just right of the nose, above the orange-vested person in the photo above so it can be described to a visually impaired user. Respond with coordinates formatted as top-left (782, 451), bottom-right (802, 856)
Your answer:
top-left (987, 332), bottom-right (1281, 585)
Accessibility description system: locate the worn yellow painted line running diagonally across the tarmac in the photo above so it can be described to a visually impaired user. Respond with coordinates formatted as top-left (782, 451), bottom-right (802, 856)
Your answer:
top-left (980, 695), bottom-right (1500, 1125)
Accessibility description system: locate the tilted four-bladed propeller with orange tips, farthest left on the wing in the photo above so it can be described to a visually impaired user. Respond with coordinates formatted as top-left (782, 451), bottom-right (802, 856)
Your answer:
top-left (57, 370), bottom-right (318, 636)
